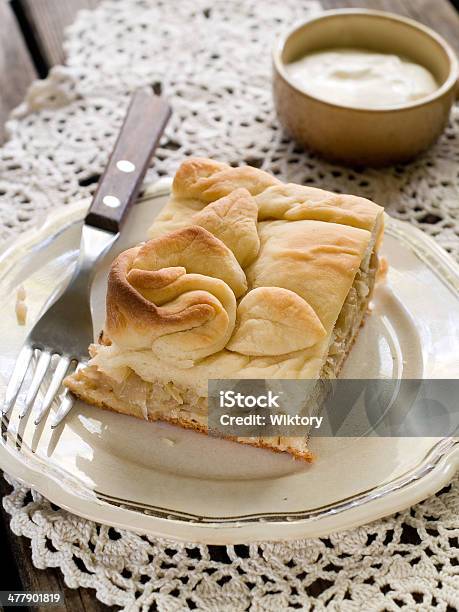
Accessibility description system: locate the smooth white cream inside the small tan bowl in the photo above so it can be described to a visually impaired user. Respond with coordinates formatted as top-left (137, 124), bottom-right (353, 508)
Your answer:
top-left (287, 48), bottom-right (438, 108)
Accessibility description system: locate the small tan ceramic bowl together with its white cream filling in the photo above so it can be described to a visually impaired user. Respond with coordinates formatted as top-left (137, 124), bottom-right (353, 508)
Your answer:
top-left (273, 9), bottom-right (459, 166)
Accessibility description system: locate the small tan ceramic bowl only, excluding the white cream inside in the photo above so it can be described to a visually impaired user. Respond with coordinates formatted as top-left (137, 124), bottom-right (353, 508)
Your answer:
top-left (273, 9), bottom-right (459, 166)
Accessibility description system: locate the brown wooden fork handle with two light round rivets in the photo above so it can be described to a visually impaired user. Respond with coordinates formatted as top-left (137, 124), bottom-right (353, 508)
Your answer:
top-left (85, 88), bottom-right (171, 233)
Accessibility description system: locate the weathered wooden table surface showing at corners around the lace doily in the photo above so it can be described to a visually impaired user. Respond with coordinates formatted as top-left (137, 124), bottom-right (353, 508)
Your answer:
top-left (0, 0), bottom-right (459, 612)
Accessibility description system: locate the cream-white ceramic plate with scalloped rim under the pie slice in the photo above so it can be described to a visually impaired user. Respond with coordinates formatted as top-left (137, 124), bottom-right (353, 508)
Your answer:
top-left (0, 181), bottom-right (459, 544)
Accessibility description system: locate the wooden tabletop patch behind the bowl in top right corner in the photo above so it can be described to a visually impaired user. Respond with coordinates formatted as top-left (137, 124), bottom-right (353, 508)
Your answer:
top-left (321, 0), bottom-right (459, 54)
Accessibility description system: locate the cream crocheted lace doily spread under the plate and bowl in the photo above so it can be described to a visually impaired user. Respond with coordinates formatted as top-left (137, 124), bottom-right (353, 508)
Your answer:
top-left (0, 0), bottom-right (459, 612)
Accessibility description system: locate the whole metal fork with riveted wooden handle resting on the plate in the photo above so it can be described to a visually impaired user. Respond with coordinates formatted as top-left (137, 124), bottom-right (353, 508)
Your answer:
top-left (2, 89), bottom-right (171, 427)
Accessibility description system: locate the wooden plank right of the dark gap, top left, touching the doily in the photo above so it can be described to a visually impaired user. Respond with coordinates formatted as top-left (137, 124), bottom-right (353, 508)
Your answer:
top-left (18, 0), bottom-right (100, 67)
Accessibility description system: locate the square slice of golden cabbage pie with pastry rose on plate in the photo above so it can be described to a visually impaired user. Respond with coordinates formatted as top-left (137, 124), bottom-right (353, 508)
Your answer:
top-left (66, 158), bottom-right (383, 460)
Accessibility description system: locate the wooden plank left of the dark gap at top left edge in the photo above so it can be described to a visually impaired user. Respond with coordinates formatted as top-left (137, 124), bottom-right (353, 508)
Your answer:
top-left (0, 0), bottom-right (36, 144)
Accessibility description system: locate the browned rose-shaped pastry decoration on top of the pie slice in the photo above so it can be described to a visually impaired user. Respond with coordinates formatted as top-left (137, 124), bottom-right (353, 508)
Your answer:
top-left (105, 226), bottom-right (247, 359)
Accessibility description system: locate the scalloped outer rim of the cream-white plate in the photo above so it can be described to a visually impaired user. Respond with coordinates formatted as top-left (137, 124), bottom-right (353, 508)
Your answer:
top-left (0, 178), bottom-right (459, 544)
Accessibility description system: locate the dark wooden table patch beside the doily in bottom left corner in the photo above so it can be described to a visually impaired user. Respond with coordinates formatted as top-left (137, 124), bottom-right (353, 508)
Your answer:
top-left (0, 473), bottom-right (114, 612)
